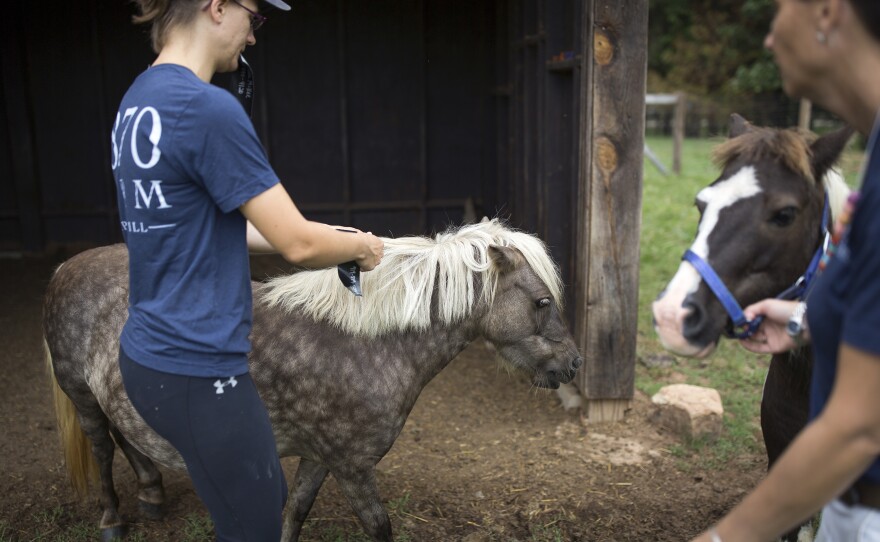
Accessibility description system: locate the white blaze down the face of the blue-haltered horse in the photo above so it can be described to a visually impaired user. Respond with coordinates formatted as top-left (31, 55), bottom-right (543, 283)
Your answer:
top-left (652, 166), bottom-right (761, 357)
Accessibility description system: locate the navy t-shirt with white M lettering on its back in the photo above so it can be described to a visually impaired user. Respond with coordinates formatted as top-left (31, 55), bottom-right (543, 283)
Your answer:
top-left (111, 64), bottom-right (278, 377)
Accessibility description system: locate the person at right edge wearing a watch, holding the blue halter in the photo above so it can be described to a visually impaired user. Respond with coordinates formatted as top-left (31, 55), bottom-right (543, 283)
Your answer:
top-left (697, 0), bottom-right (880, 542)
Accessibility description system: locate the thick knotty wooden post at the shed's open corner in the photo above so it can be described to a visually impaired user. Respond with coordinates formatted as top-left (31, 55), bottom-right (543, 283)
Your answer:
top-left (574, 0), bottom-right (648, 421)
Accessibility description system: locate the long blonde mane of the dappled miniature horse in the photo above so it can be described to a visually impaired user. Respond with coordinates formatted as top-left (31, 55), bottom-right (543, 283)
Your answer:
top-left (255, 219), bottom-right (562, 337)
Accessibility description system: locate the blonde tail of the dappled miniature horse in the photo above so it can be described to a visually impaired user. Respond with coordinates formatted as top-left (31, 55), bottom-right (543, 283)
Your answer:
top-left (43, 339), bottom-right (99, 497)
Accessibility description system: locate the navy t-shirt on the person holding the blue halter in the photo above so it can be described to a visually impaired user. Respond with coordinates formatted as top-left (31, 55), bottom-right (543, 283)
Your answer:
top-left (807, 118), bottom-right (880, 484)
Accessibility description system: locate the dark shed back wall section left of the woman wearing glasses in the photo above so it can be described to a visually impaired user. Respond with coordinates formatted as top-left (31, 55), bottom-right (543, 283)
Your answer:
top-left (0, 2), bottom-right (149, 251)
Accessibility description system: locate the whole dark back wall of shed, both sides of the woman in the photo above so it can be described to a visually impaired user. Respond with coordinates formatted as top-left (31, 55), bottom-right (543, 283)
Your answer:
top-left (0, 0), bottom-right (503, 251)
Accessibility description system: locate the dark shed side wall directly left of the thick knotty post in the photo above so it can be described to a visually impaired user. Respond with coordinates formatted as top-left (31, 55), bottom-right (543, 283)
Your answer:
top-left (502, 0), bottom-right (584, 322)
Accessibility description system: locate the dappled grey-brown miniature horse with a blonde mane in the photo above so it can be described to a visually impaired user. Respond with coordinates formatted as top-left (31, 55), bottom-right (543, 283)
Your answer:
top-left (43, 221), bottom-right (582, 541)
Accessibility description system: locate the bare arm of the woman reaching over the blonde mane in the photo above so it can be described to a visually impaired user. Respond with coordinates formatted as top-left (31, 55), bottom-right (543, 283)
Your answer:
top-left (240, 183), bottom-right (384, 271)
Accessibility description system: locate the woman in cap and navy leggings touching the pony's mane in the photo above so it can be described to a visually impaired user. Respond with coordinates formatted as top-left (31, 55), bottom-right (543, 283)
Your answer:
top-left (111, 0), bottom-right (383, 542)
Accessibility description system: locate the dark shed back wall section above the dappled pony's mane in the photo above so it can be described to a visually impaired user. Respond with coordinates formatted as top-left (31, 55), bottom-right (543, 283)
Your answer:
top-left (255, 0), bottom-right (496, 235)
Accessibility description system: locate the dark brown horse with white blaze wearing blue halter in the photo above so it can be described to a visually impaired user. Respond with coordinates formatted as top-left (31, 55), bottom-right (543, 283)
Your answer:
top-left (653, 115), bottom-right (853, 541)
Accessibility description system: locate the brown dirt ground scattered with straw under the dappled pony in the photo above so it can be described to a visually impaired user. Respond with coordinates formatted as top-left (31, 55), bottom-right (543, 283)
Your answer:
top-left (0, 257), bottom-right (765, 542)
